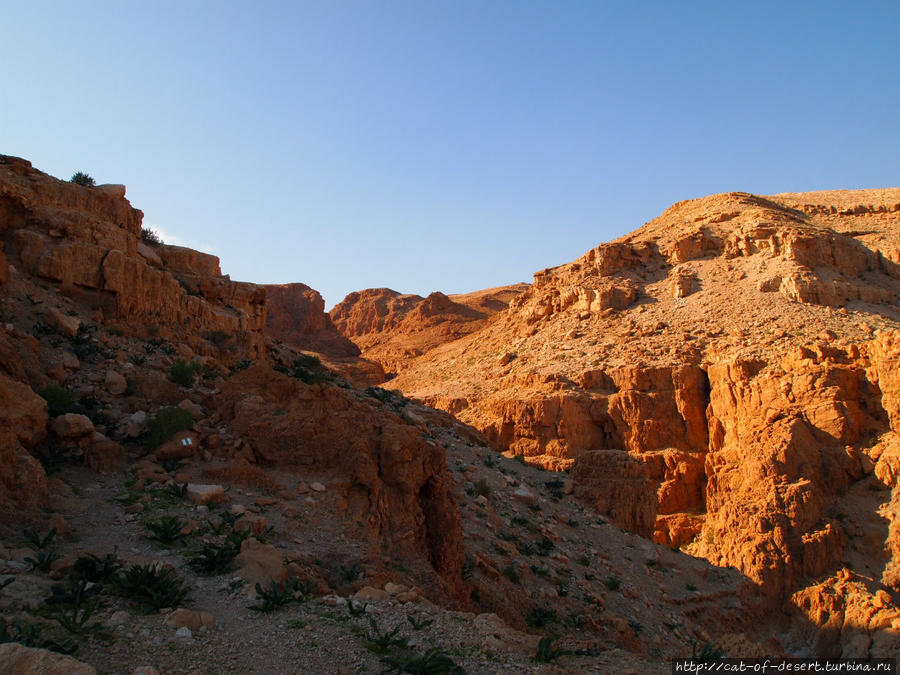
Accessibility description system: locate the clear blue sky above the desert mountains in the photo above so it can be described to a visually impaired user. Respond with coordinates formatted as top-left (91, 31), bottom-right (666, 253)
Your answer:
top-left (0, 0), bottom-right (900, 307)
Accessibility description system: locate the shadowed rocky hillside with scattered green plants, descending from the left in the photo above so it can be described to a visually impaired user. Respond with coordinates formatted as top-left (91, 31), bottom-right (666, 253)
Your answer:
top-left (0, 156), bottom-right (816, 675)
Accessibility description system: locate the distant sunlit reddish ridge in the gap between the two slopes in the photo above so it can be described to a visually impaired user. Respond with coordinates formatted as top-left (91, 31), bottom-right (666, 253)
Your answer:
top-left (330, 284), bottom-right (527, 374)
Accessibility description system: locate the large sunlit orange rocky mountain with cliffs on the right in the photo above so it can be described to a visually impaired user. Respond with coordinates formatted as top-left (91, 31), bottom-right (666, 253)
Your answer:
top-left (392, 190), bottom-right (900, 644)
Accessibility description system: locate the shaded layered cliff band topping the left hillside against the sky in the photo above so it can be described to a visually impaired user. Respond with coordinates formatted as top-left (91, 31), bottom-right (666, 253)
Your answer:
top-left (0, 155), bottom-right (265, 356)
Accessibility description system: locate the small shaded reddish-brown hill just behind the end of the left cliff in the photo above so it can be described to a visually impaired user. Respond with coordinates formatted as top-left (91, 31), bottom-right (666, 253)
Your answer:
top-left (265, 284), bottom-right (360, 358)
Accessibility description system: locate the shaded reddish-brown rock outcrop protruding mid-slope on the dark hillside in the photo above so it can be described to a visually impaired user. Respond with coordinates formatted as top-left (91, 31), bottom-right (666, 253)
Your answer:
top-left (216, 365), bottom-right (463, 594)
